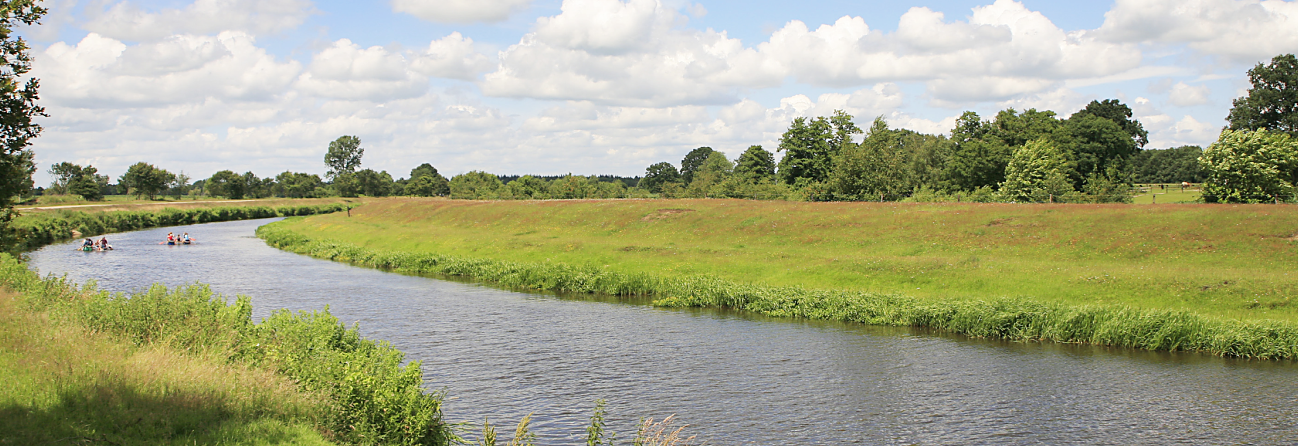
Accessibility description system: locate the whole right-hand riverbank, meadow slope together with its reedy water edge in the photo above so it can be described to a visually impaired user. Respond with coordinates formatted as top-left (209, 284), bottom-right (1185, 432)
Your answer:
top-left (261, 198), bottom-right (1298, 358)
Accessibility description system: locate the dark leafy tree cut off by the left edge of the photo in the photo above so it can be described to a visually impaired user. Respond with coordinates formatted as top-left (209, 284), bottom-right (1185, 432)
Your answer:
top-left (0, 0), bottom-right (47, 252)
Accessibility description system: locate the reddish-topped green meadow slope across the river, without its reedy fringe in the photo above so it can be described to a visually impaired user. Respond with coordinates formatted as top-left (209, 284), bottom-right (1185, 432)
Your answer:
top-left (273, 198), bottom-right (1298, 322)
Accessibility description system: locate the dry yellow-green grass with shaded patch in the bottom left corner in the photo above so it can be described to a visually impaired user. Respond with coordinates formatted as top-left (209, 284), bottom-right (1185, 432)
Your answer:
top-left (0, 290), bottom-right (331, 445)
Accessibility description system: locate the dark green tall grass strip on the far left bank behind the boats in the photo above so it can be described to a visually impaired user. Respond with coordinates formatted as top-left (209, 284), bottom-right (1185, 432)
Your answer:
top-left (12, 204), bottom-right (347, 250)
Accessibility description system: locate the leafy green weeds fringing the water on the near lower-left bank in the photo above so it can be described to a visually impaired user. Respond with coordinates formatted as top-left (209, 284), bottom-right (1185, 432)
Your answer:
top-left (0, 254), bottom-right (454, 445)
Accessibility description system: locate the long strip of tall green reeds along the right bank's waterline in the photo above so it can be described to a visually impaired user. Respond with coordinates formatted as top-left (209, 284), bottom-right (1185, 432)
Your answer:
top-left (257, 223), bottom-right (1298, 359)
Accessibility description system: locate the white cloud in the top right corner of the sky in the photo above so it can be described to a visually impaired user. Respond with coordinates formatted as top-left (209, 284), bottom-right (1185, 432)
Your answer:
top-left (1096, 0), bottom-right (1298, 62)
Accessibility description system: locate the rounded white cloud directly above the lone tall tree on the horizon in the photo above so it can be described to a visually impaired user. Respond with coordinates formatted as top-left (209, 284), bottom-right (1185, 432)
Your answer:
top-left (297, 39), bottom-right (428, 101)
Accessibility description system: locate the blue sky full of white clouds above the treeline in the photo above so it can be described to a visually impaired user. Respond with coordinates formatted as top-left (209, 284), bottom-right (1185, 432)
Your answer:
top-left (19, 0), bottom-right (1298, 185)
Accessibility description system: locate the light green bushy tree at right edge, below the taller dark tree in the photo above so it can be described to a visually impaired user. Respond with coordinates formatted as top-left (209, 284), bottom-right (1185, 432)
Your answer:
top-left (1199, 130), bottom-right (1298, 202)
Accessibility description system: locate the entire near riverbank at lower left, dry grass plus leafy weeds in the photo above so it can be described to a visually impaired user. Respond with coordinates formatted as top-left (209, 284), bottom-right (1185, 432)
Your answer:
top-left (0, 254), bottom-right (453, 445)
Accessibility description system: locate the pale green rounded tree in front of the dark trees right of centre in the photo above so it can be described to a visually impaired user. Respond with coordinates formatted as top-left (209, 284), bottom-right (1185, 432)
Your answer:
top-left (1001, 139), bottom-right (1076, 202)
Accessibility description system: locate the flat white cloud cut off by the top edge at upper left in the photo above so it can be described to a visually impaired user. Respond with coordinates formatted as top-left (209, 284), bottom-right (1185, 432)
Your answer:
top-left (82, 0), bottom-right (315, 41)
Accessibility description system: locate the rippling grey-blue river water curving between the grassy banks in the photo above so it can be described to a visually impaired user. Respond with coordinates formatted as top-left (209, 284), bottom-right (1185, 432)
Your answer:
top-left (30, 220), bottom-right (1298, 445)
